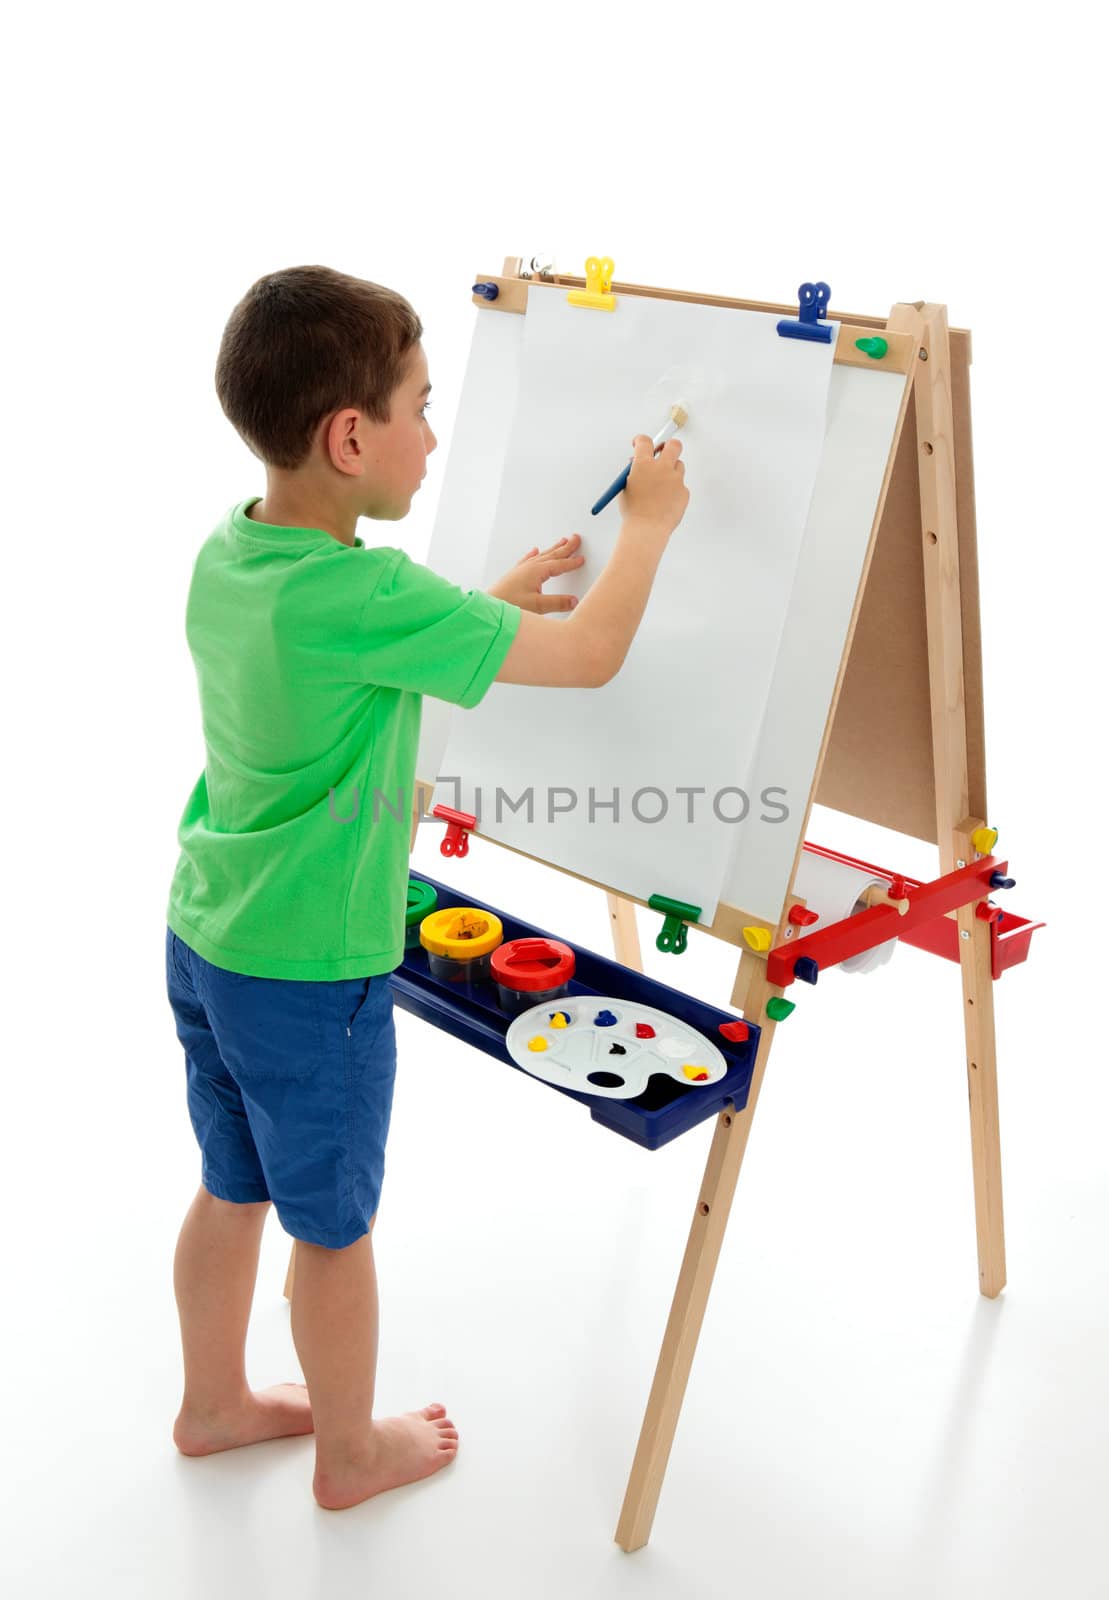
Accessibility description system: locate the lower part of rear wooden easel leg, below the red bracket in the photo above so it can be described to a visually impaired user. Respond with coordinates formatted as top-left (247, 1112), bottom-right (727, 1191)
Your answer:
top-left (955, 819), bottom-right (1005, 1299)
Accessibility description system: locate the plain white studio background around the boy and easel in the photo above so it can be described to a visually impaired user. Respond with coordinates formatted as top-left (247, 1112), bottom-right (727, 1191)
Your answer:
top-left (0, 3), bottom-right (1109, 1600)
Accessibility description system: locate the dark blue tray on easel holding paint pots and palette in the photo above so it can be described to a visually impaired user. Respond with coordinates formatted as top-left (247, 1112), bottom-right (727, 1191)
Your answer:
top-left (389, 872), bottom-right (759, 1150)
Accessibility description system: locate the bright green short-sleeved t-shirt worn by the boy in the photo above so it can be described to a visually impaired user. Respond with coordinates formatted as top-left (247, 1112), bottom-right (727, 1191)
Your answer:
top-left (166, 496), bottom-right (520, 979)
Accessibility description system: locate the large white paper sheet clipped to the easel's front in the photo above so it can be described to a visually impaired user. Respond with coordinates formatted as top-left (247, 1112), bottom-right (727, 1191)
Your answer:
top-left (422, 288), bottom-right (835, 922)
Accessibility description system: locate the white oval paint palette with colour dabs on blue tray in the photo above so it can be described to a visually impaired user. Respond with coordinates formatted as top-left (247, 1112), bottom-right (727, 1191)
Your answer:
top-left (504, 995), bottom-right (728, 1099)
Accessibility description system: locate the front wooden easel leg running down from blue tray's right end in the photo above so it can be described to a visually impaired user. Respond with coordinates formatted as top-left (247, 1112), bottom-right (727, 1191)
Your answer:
top-left (615, 955), bottom-right (776, 1552)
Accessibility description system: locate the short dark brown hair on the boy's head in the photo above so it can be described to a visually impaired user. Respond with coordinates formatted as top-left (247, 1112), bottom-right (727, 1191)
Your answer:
top-left (216, 267), bottom-right (424, 469)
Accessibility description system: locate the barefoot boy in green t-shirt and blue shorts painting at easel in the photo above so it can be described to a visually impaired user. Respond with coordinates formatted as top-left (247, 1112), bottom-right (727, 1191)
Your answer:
top-left (166, 267), bottom-right (688, 1509)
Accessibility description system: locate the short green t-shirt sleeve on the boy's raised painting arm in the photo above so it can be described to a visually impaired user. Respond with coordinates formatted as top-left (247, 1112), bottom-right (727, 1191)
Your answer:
top-left (355, 550), bottom-right (520, 709)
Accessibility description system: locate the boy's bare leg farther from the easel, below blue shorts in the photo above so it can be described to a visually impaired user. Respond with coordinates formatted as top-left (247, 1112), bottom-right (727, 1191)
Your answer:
top-left (173, 1187), bottom-right (312, 1456)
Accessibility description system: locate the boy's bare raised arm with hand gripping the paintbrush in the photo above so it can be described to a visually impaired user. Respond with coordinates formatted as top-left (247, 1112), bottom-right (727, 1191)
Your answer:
top-left (496, 434), bottom-right (690, 688)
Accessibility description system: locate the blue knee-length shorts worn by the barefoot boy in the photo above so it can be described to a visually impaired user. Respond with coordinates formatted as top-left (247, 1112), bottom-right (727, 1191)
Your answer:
top-left (165, 928), bottom-right (397, 1250)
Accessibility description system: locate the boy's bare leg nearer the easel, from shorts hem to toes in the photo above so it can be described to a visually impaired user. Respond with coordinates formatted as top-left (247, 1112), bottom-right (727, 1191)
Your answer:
top-left (291, 1221), bottom-right (458, 1510)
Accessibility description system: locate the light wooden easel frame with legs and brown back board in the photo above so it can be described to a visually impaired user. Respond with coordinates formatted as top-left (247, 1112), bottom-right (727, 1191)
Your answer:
top-left (285, 258), bottom-right (1005, 1552)
